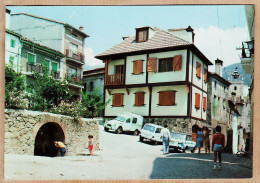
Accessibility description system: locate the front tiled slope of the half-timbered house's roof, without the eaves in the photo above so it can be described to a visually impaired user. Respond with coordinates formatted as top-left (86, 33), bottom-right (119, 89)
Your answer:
top-left (96, 27), bottom-right (192, 58)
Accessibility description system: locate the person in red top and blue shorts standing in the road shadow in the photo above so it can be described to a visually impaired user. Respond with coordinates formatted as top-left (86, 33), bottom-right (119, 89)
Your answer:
top-left (212, 126), bottom-right (225, 169)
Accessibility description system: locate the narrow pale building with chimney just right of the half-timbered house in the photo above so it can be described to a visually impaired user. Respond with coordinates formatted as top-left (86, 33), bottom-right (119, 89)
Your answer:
top-left (207, 59), bottom-right (232, 146)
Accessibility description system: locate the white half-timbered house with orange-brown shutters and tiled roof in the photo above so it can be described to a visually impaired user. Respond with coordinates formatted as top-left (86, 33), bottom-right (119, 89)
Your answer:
top-left (96, 27), bottom-right (212, 133)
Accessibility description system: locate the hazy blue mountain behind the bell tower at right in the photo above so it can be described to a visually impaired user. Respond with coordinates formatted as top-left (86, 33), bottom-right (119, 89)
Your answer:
top-left (222, 63), bottom-right (251, 85)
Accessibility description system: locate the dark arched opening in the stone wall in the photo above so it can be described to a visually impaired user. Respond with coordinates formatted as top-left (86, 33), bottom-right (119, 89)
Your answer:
top-left (34, 122), bottom-right (65, 157)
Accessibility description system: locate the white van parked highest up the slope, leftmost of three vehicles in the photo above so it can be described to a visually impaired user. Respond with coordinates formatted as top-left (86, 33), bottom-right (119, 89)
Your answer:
top-left (104, 112), bottom-right (143, 135)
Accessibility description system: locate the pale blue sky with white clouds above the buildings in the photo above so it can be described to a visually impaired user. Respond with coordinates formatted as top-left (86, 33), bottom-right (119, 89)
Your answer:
top-left (7, 5), bottom-right (249, 71)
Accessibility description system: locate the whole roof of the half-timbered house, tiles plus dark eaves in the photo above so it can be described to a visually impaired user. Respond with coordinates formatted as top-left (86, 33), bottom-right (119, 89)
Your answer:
top-left (96, 27), bottom-right (213, 65)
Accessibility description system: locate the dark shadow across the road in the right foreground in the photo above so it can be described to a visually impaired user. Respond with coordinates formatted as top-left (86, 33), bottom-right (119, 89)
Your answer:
top-left (150, 153), bottom-right (252, 179)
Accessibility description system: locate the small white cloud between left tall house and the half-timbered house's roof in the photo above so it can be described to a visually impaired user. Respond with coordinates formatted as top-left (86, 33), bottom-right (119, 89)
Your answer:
top-left (83, 47), bottom-right (105, 69)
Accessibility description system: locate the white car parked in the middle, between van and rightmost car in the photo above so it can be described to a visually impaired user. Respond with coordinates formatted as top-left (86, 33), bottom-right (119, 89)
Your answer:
top-left (139, 123), bottom-right (163, 144)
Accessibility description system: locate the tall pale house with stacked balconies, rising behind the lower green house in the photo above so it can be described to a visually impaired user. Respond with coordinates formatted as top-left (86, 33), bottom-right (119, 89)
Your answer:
top-left (10, 13), bottom-right (88, 98)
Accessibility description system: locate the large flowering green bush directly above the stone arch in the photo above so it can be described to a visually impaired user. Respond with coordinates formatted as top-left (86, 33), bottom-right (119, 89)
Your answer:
top-left (28, 64), bottom-right (72, 111)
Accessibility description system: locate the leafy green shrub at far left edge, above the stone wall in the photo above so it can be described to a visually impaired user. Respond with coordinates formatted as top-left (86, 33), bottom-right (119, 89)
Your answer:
top-left (5, 65), bottom-right (28, 109)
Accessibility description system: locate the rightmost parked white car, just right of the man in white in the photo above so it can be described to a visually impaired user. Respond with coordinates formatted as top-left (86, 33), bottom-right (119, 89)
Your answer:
top-left (170, 132), bottom-right (196, 153)
